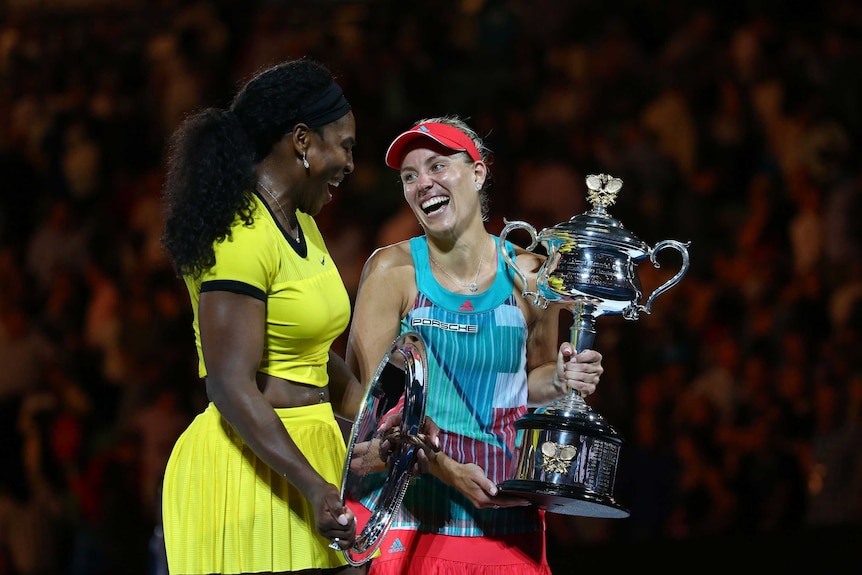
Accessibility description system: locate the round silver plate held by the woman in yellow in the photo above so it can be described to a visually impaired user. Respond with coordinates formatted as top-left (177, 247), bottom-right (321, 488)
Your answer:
top-left (341, 331), bottom-right (428, 566)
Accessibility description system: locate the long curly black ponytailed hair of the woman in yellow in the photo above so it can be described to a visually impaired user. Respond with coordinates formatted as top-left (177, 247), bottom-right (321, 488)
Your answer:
top-left (162, 58), bottom-right (333, 277)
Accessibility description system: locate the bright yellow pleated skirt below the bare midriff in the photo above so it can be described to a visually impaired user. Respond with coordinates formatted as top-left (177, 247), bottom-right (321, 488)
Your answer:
top-left (162, 403), bottom-right (347, 575)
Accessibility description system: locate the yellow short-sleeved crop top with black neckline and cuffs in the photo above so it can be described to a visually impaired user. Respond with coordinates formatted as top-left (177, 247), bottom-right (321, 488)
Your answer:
top-left (184, 194), bottom-right (350, 387)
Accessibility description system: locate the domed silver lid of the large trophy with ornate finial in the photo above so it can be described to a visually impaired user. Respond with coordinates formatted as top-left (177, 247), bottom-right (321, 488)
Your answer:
top-left (540, 174), bottom-right (649, 259)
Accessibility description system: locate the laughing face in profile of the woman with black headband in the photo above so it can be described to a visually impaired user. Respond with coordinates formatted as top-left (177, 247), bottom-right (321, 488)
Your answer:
top-left (297, 112), bottom-right (356, 216)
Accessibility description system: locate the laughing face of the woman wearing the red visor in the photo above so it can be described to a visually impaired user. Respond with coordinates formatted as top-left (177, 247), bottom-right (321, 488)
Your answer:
top-left (401, 144), bottom-right (485, 235)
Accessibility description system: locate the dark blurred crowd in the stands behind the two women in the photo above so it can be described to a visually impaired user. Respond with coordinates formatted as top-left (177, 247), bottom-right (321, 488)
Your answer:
top-left (0, 0), bottom-right (862, 575)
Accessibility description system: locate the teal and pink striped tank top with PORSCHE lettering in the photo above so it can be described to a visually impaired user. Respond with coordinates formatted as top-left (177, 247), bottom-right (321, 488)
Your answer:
top-left (392, 236), bottom-right (542, 536)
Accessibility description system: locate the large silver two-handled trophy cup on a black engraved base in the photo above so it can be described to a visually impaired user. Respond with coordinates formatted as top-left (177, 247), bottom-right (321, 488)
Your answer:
top-left (499, 174), bottom-right (689, 518)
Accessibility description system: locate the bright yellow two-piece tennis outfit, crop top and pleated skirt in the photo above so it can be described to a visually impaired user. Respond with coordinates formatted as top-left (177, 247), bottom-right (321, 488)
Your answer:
top-left (162, 195), bottom-right (350, 575)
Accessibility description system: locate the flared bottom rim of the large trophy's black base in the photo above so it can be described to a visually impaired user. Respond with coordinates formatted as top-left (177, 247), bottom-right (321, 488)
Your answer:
top-left (500, 479), bottom-right (629, 519)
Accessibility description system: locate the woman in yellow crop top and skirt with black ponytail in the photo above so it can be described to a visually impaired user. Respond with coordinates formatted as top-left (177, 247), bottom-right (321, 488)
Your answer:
top-left (162, 59), bottom-right (364, 575)
